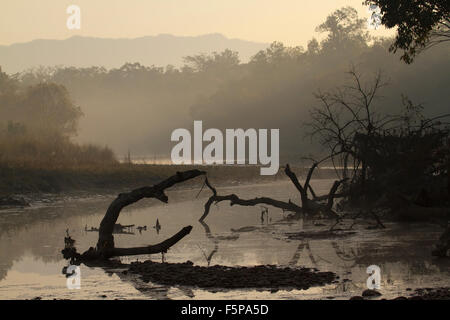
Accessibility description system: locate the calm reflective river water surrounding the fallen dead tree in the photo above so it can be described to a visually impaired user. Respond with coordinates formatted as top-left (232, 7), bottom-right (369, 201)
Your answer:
top-left (0, 180), bottom-right (450, 299)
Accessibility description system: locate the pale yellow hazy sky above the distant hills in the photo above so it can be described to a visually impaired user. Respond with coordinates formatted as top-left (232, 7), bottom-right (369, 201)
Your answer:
top-left (0, 0), bottom-right (394, 45)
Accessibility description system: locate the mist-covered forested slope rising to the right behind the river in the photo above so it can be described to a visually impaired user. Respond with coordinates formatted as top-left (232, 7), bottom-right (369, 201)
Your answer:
top-left (6, 7), bottom-right (450, 161)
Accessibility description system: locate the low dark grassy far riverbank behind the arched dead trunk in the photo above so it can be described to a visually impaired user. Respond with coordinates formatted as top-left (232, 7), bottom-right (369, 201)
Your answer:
top-left (0, 164), bottom-right (340, 197)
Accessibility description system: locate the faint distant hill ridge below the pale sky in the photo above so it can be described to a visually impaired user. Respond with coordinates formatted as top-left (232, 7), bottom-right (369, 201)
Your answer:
top-left (0, 34), bottom-right (268, 73)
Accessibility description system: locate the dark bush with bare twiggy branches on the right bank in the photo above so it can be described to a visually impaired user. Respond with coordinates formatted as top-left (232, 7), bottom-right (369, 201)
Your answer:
top-left (308, 69), bottom-right (450, 206)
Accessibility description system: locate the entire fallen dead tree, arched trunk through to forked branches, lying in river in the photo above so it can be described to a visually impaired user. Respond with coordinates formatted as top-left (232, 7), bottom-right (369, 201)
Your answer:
top-left (63, 162), bottom-right (343, 261)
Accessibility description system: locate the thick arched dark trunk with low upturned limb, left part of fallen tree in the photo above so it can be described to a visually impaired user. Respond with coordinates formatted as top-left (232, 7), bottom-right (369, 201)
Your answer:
top-left (63, 170), bottom-right (206, 261)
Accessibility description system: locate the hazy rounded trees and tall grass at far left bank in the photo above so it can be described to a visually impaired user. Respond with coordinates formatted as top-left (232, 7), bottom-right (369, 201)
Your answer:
top-left (0, 73), bottom-right (116, 168)
